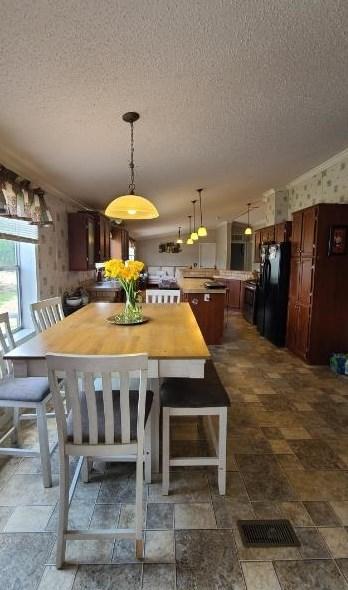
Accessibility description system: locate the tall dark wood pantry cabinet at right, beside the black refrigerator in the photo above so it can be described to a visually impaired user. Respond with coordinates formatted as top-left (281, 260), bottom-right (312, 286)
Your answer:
top-left (287, 204), bottom-right (348, 364)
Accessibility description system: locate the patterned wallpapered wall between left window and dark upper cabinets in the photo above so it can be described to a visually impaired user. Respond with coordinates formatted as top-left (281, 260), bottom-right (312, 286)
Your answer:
top-left (38, 195), bottom-right (94, 299)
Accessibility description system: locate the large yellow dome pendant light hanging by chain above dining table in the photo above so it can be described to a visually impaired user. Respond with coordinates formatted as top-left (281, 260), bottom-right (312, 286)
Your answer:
top-left (105, 113), bottom-right (159, 219)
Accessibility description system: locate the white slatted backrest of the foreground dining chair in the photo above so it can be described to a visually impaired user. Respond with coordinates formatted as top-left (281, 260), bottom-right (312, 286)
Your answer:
top-left (46, 353), bottom-right (148, 454)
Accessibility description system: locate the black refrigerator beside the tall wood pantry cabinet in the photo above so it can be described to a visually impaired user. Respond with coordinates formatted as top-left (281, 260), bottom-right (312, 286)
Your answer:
top-left (257, 242), bottom-right (291, 346)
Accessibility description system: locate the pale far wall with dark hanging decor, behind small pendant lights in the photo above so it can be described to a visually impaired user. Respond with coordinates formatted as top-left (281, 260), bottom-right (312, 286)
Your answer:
top-left (136, 230), bottom-right (215, 266)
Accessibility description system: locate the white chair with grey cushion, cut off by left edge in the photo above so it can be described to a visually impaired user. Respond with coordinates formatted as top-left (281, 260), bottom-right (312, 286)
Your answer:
top-left (0, 313), bottom-right (56, 488)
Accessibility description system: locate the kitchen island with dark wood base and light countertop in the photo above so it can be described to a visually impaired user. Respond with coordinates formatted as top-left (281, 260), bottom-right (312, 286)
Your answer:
top-left (178, 277), bottom-right (226, 344)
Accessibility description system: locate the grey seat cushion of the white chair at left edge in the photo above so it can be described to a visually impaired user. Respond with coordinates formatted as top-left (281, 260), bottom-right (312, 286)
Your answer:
top-left (0, 377), bottom-right (50, 403)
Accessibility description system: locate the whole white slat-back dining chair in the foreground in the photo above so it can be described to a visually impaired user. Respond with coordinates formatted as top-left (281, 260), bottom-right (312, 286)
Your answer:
top-left (46, 353), bottom-right (153, 568)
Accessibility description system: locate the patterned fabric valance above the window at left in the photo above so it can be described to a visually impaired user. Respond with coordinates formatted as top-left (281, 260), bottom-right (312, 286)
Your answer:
top-left (0, 164), bottom-right (53, 226)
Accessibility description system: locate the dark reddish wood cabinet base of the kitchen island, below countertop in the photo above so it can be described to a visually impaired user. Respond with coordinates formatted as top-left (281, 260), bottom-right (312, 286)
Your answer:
top-left (182, 293), bottom-right (225, 344)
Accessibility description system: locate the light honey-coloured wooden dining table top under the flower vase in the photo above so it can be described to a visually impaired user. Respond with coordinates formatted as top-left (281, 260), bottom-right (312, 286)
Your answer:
top-left (6, 302), bottom-right (210, 361)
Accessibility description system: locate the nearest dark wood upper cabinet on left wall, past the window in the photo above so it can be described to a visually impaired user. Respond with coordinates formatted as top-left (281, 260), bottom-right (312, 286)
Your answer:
top-left (68, 211), bottom-right (110, 270)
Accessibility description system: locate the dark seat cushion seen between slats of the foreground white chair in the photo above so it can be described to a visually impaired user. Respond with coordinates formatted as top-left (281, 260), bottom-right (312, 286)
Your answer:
top-left (67, 391), bottom-right (153, 443)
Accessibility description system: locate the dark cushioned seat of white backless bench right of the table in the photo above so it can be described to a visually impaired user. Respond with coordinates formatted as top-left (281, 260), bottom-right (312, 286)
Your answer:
top-left (161, 361), bottom-right (231, 408)
